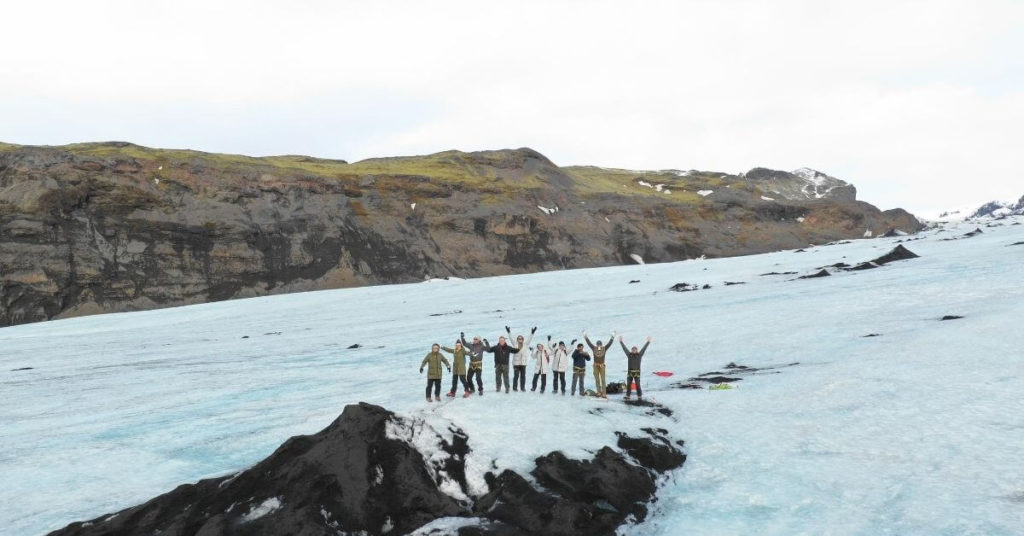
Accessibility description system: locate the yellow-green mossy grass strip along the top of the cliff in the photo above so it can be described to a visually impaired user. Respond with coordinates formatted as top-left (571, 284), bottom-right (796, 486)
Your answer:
top-left (9, 141), bottom-right (737, 205)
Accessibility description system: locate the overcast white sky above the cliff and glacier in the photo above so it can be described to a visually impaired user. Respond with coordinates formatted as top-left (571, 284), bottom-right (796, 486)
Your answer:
top-left (0, 0), bottom-right (1024, 212)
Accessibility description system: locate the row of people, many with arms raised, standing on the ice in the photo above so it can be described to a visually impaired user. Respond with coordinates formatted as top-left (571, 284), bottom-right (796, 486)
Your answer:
top-left (420, 326), bottom-right (650, 402)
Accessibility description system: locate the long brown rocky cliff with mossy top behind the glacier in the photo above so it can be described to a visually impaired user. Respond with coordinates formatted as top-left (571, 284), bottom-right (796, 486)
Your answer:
top-left (0, 142), bottom-right (921, 325)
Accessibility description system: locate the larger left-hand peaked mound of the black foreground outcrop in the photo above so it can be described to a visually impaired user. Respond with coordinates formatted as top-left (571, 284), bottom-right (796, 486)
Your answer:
top-left (52, 403), bottom-right (468, 536)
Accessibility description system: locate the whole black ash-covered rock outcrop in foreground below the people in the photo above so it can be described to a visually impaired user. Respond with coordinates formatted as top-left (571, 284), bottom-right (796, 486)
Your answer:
top-left (51, 403), bottom-right (686, 536)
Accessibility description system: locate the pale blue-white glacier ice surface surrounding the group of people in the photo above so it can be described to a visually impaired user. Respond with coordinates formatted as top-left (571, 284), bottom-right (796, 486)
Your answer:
top-left (0, 218), bottom-right (1024, 536)
